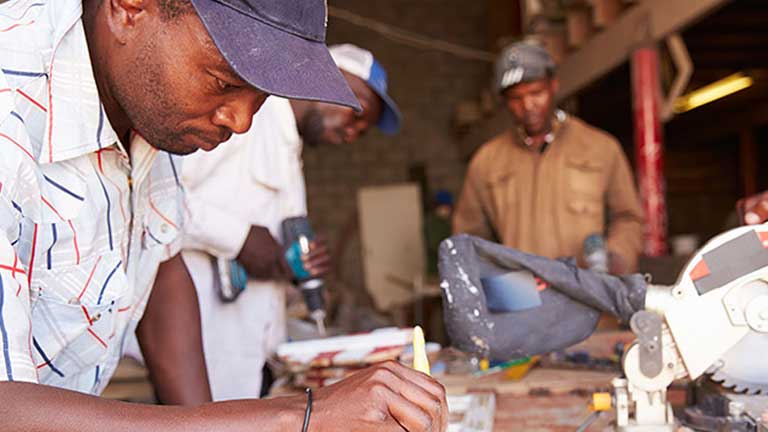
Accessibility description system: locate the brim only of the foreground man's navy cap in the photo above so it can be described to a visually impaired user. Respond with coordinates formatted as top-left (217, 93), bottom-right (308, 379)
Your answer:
top-left (192, 0), bottom-right (361, 111)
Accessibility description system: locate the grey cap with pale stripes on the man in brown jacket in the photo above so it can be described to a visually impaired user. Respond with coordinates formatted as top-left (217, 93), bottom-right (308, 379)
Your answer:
top-left (494, 42), bottom-right (555, 93)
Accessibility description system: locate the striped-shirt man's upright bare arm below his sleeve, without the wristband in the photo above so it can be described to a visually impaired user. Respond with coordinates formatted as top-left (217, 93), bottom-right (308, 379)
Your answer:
top-left (136, 254), bottom-right (211, 405)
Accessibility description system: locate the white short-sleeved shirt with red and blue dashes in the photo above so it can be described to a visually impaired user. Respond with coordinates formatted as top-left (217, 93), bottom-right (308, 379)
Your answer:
top-left (0, 0), bottom-right (183, 394)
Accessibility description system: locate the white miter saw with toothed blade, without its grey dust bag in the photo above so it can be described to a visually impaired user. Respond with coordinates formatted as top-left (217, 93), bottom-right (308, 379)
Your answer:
top-left (613, 225), bottom-right (768, 432)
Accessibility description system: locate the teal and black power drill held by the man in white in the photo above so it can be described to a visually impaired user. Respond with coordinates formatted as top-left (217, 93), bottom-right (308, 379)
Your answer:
top-left (282, 216), bottom-right (326, 336)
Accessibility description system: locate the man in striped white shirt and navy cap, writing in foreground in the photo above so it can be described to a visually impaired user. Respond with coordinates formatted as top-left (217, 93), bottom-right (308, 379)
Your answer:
top-left (0, 0), bottom-right (447, 432)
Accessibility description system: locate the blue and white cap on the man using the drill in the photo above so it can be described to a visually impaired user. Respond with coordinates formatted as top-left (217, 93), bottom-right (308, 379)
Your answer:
top-left (329, 44), bottom-right (400, 135)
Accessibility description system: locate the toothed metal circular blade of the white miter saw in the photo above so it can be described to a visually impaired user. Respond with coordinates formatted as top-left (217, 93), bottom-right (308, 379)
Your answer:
top-left (707, 331), bottom-right (768, 395)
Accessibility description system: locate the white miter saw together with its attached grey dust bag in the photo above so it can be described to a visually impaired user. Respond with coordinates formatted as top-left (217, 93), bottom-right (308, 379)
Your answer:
top-left (440, 225), bottom-right (768, 432)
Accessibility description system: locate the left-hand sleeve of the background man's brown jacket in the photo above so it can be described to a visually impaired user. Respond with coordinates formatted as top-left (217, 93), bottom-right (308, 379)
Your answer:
top-left (453, 160), bottom-right (494, 240)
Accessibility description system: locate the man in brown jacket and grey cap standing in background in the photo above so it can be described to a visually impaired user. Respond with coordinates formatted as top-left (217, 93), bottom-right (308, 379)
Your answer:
top-left (453, 42), bottom-right (643, 274)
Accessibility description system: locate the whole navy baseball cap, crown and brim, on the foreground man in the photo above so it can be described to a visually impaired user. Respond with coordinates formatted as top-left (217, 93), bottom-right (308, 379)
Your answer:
top-left (192, 0), bottom-right (361, 111)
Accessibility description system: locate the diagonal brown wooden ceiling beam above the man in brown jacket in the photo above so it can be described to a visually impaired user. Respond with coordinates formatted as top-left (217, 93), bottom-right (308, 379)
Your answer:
top-left (558, 0), bottom-right (730, 99)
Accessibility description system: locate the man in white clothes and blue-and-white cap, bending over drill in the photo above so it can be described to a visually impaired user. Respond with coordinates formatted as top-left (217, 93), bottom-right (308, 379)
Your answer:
top-left (181, 44), bottom-right (400, 400)
